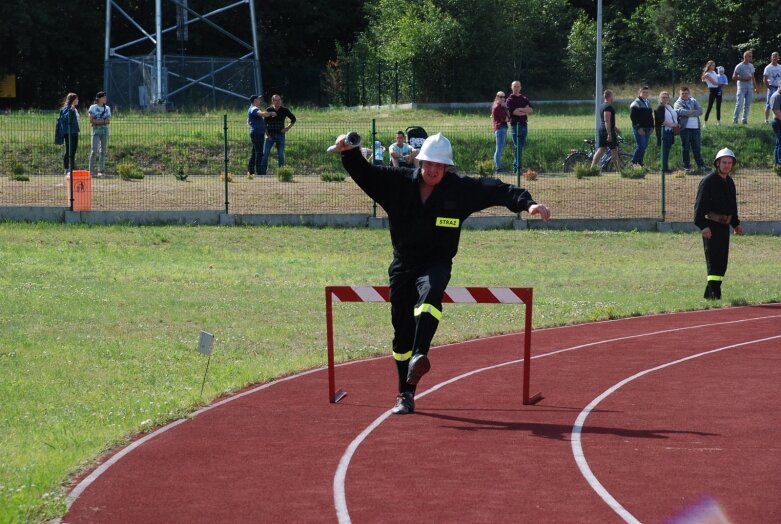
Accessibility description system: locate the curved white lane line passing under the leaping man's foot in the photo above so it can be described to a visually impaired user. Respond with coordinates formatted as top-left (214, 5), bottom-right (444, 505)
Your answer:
top-left (333, 310), bottom-right (781, 524)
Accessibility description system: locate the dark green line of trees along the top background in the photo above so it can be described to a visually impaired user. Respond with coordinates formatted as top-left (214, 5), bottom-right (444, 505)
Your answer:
top-left (0, 0), bottom-right (781, 108)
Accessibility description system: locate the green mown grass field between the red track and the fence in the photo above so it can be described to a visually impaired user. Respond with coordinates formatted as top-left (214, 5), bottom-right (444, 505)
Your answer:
top-left (0, 223), bottom-right (781, 522)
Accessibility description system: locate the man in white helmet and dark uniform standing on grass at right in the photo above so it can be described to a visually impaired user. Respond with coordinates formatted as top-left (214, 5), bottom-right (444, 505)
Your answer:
top-left (694, 148), bottom-right (743, 300)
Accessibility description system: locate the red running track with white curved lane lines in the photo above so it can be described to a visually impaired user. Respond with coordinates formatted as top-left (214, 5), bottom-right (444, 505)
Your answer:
top-left (63, 305), bottom-right (781, 523)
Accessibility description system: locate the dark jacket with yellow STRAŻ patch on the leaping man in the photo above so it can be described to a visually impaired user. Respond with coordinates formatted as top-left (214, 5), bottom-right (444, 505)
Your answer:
top-left (342, 148), bottom-right (536, 266)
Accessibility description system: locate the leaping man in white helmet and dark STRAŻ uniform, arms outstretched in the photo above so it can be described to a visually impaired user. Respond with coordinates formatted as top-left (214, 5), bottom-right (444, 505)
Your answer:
top-left (334, 133), bottom-right (550, 414)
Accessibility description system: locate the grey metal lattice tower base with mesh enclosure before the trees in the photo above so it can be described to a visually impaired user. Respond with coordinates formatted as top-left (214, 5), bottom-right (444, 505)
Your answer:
top-left (104, 0), bottom-right (263, 108)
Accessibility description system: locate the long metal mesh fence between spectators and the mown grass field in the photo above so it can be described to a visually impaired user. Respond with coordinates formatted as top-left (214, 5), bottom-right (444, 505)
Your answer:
top-left (0, 112), bottom-right (781, 221)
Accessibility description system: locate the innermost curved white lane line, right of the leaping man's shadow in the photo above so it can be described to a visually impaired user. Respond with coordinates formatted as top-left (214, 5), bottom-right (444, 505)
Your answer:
top-left (571, 335), bottom-right (781, 524)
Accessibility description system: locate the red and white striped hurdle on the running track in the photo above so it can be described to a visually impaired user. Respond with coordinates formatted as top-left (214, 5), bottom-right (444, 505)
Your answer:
top-left (325, 286), bottom-right (542, 405)
